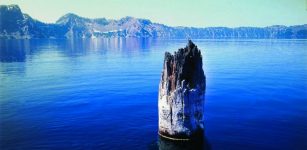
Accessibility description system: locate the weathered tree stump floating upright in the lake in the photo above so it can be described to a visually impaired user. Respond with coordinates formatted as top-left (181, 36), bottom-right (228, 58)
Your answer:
top-left (158, 40), bottom-right (206, 138)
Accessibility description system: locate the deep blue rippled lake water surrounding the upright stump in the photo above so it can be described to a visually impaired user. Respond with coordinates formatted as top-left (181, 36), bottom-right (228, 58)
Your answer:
top-left (0, 38), bottom-right (307, 150)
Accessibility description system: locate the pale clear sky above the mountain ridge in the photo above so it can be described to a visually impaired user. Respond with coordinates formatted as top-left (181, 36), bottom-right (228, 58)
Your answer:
top-left (0, 0), bottom-right (307, 27)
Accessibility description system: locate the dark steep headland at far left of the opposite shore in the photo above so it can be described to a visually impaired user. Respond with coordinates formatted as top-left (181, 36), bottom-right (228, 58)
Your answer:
top-left (0, 5), bottom-right (66, 39)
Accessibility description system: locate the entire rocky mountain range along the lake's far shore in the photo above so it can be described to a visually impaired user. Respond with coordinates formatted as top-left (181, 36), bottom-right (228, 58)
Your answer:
top-left (0, 5), bottom-right (307, 39)
